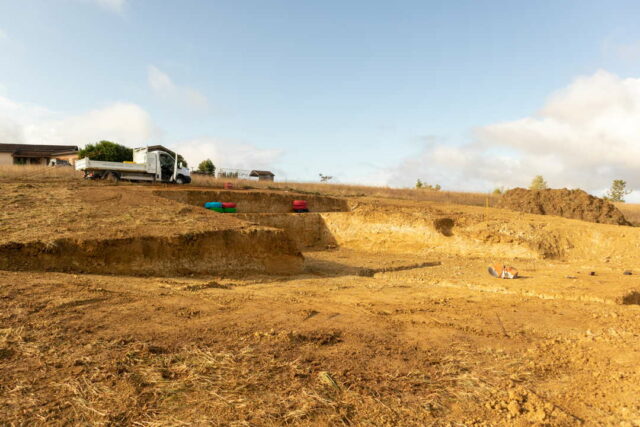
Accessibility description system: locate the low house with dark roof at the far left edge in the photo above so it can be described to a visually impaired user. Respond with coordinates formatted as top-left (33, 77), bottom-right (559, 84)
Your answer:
top-left (0, 144), bottom-right (78, 166)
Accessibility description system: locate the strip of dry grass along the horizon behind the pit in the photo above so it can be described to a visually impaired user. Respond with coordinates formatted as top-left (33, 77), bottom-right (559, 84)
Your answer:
top-left (193, 175), bottom-right (500, 206)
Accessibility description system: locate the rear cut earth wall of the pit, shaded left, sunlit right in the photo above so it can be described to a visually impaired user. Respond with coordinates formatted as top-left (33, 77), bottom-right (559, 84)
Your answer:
top-left (156, 191), bottom-right (638, 260)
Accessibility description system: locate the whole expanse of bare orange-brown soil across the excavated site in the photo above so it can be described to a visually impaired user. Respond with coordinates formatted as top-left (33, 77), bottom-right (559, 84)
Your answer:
top-left (0, 183), bottom-right (640, 425)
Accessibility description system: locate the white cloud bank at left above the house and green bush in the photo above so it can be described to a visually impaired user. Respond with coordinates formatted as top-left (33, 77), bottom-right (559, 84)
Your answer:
top-left (0, 96), bottom-right (159, 146)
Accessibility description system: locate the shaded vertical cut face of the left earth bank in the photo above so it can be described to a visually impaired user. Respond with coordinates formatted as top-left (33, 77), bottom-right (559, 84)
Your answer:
top-left (0, 227), bottom-right (304, 276)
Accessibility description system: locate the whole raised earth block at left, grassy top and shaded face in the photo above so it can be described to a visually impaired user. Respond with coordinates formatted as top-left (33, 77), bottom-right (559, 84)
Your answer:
top-left (0, 184), bottom-right (304, 276)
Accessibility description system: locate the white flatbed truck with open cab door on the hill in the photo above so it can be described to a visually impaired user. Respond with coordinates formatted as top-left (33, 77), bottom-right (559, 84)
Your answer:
top-left (76, 146), bottom-right (191, 184)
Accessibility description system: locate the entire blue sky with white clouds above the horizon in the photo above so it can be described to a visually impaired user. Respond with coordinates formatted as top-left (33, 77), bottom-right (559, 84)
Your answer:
top-left (0, 0), bottom-right (640, 201)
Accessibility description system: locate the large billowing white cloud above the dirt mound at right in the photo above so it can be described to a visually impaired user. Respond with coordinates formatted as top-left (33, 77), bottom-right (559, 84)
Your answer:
top-left (390, 71), bottom-right (640, 198)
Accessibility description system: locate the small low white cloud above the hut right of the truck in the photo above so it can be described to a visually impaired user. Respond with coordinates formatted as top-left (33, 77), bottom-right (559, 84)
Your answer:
top-left (176, 137), bottom-right (282, 169)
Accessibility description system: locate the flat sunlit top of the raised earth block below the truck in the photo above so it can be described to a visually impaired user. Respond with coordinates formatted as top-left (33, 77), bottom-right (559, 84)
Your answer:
top-left (0, 183), bottom-right (244, 244)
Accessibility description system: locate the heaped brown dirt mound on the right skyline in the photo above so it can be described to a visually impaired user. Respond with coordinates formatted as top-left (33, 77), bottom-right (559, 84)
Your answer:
top-left (498, 188), bottom-right (631, 225)
